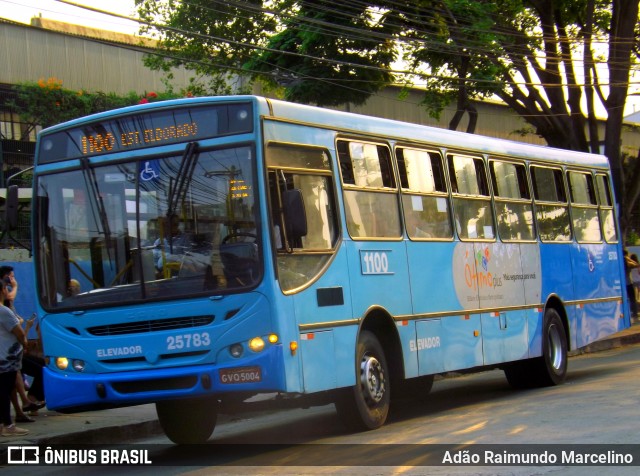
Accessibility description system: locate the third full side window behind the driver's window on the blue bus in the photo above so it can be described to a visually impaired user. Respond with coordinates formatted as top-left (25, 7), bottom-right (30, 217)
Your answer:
top-left (447, 154), bottom-right (495, 240)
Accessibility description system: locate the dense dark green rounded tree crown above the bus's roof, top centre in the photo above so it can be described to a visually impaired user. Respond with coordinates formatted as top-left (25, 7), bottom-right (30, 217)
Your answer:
top-left (244, 1), bottom-right (396, 106)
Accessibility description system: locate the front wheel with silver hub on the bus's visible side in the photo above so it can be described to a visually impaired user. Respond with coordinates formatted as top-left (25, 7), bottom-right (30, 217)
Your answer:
top-left (335, 331), bottom-right (390, 431)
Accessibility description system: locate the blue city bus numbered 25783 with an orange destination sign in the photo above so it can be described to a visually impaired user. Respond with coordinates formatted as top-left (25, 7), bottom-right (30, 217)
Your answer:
top-left (11, 96), bottom-right (629, 443)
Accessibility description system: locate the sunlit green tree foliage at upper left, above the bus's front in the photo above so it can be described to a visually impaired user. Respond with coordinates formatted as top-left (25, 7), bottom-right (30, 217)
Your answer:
top-left (136, 0), bottom-right (272, 95)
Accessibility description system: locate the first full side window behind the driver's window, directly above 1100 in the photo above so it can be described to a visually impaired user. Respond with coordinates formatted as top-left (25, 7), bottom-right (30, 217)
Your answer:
top-left (338, 140), bottom-right (402, 238)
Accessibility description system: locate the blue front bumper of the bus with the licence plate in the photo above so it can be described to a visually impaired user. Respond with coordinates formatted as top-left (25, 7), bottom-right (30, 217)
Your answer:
top-left (43, 345), bottom-right (285, 412)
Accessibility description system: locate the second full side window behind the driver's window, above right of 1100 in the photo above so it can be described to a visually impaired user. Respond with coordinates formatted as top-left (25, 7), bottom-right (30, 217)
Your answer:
top-left (396, 147), bottom-right (453, 240)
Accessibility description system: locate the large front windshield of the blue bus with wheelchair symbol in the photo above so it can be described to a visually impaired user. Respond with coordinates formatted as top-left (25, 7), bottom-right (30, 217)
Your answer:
top-left (34, 142), bottom-right (262, 311)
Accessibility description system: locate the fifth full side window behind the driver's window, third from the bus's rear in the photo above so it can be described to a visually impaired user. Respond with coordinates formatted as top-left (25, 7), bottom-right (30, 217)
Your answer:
top-left (530, 165), bottom-right (571, 241)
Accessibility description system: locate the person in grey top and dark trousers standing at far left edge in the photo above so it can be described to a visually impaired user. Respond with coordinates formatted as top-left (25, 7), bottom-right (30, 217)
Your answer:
top-left (0, 281), bottom-right (29, 436)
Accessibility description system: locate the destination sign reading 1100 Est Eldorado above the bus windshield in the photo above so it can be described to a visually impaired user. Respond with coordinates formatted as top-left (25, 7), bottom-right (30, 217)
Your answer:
top-left (37, 103), bottom-right (253, 164)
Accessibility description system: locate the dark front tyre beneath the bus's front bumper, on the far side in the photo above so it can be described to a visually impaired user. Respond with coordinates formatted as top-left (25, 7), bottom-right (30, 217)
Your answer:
top-left (156, 398), bottom-right (218, 445)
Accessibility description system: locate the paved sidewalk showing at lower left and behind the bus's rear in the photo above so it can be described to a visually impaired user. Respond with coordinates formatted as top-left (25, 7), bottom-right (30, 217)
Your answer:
top-left (0, 322), bottom-right (640, 445)
